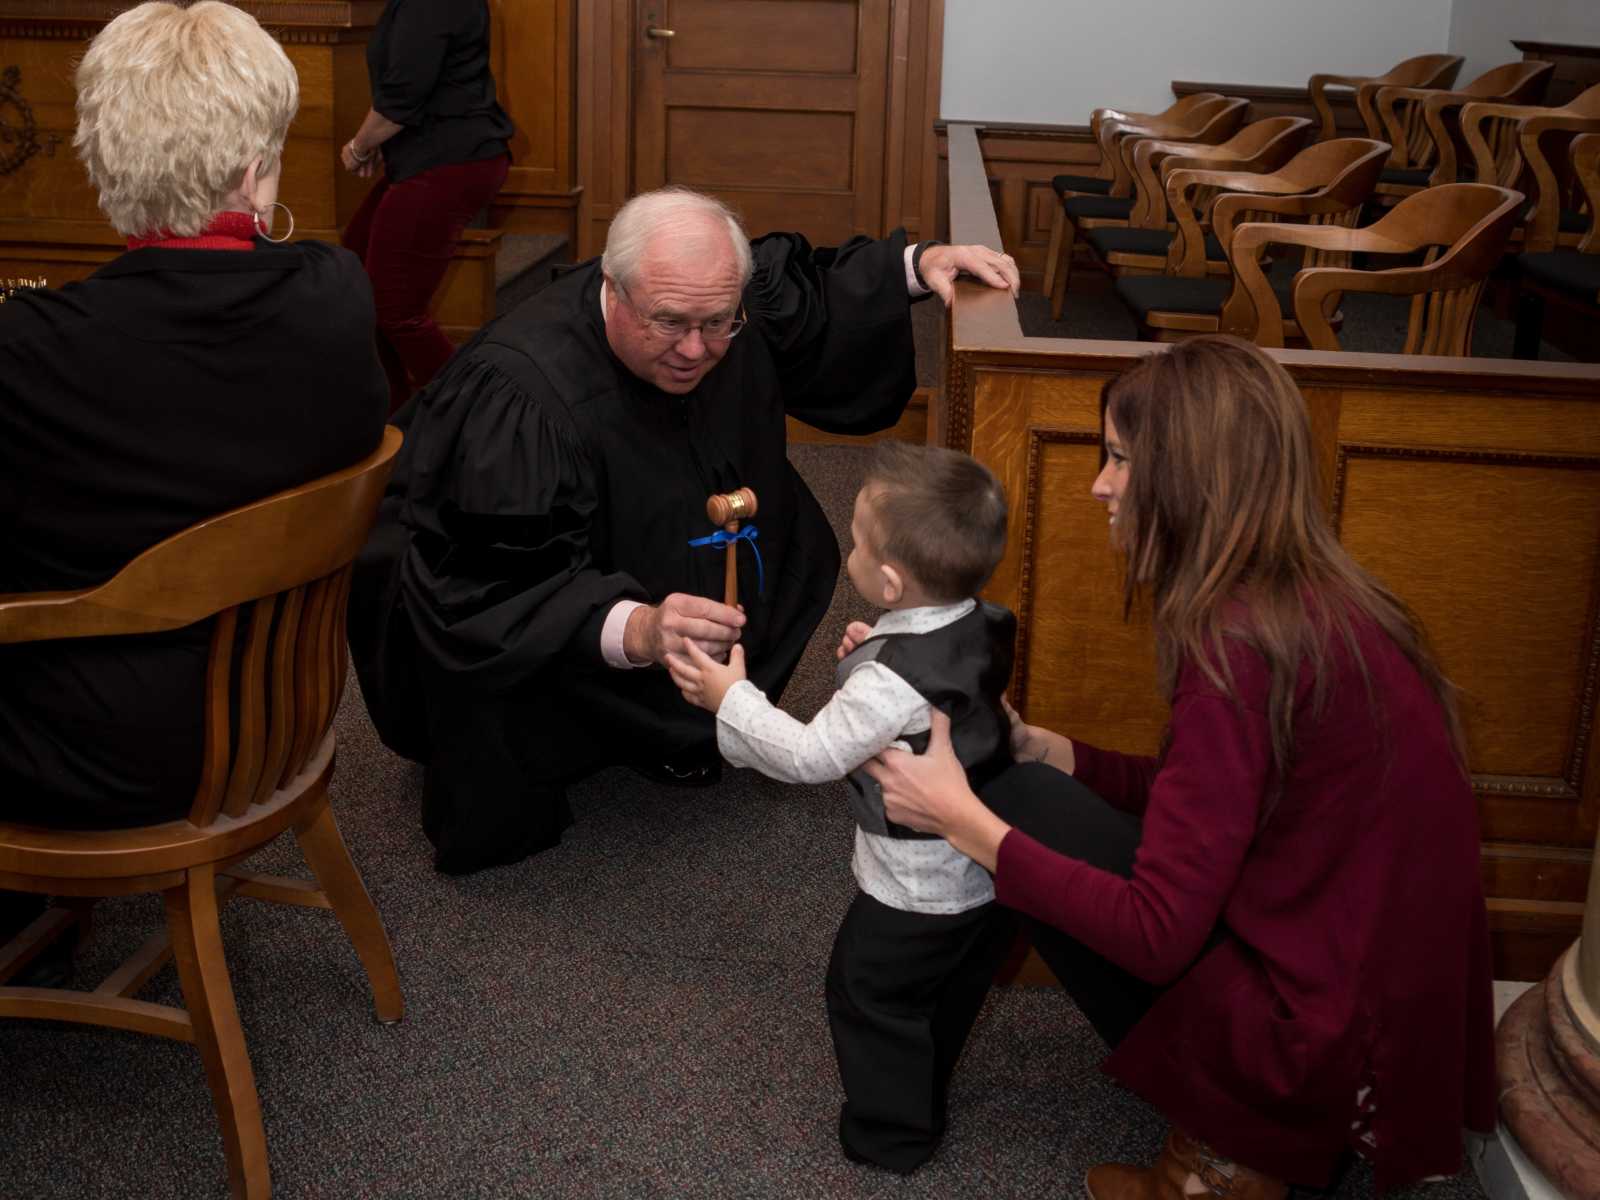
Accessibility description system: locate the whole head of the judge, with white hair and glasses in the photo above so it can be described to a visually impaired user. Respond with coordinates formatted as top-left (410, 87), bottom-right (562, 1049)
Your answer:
top-left (600, 187), bottom-right (750, 395)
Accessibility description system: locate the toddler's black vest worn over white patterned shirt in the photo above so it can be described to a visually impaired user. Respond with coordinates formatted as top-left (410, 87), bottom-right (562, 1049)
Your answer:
top-left (838, 600), bottom-right (1016, 838)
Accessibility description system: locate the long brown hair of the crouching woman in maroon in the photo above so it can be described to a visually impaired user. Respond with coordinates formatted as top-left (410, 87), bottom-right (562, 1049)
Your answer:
top-left (1101, 336), bottom-right (1464, 779)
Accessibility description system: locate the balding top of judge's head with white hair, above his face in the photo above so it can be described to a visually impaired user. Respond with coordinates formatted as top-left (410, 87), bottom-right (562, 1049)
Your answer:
top-left (600, 187), bottom-right (750, 299)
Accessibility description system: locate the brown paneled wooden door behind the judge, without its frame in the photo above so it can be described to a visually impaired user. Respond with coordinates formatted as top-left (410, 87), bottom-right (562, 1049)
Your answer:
top-left (632, 0), bottom-right (890, 245)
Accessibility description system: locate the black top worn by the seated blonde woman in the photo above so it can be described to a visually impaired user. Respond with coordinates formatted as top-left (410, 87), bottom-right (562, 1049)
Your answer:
top-left (0, 242), bottom-right (387, 826)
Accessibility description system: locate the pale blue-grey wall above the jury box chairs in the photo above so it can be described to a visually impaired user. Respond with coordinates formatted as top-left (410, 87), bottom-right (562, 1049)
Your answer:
top-left (941, 0), bottom-right (1465, 125)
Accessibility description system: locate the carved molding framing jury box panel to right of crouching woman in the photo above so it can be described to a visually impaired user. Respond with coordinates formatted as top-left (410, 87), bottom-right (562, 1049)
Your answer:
top-left (1324, 442), bottom-right (1600, 803)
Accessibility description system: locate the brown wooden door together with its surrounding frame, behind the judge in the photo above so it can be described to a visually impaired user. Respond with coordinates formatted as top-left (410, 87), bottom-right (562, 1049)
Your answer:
top-left (574, 0), bottom-right (944, 258)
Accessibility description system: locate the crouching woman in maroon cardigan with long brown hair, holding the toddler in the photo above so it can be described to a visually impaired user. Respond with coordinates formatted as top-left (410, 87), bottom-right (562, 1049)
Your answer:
top-left (872, 338), bottom-right (1494, 1200)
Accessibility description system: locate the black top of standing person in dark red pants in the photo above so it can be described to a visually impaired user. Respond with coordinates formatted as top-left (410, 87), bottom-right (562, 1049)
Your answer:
top-left (366, 0), bottom-right (514, 182)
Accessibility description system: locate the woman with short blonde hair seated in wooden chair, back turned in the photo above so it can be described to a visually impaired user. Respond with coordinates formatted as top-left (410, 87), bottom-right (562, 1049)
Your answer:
top-left (0, 3), bottom-right (387, 939)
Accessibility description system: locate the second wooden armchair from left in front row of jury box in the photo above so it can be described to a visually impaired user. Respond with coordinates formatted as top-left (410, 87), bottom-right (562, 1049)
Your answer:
top-left (1067, 117), bottom-right (1312, 284)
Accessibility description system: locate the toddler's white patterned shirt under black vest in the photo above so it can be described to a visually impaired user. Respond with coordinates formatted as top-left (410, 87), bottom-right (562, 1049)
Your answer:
top-left (717, 600), bottom-right (995, 915)
